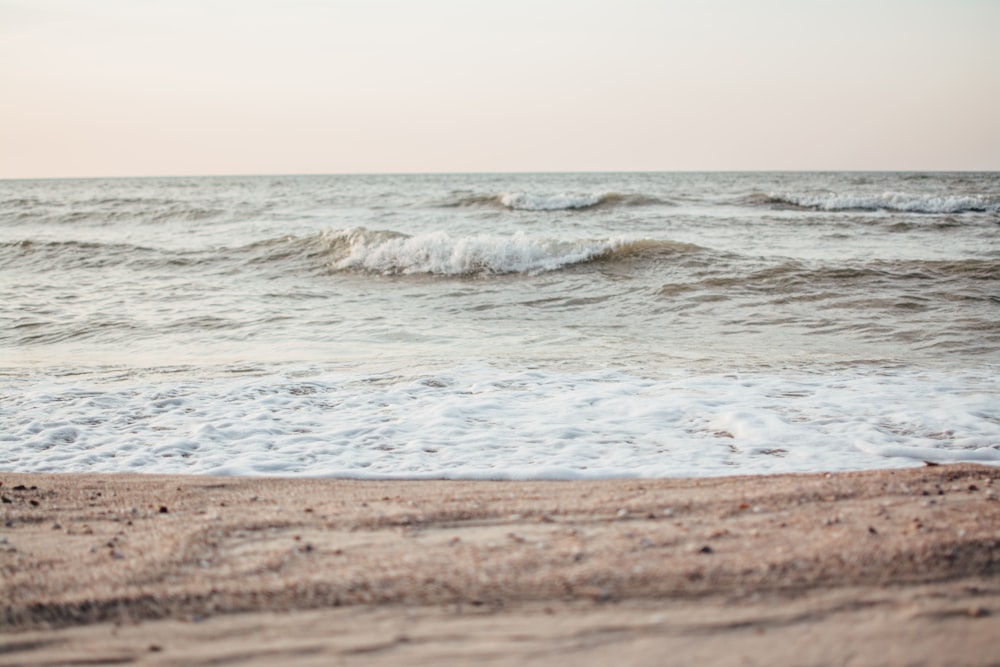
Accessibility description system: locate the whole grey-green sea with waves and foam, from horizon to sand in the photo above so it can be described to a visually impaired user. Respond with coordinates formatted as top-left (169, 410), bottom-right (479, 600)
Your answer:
top-left (0, 173), bottom-right (1000, 479)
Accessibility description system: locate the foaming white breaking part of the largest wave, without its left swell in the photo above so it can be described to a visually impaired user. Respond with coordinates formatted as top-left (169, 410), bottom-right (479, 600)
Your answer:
top-left (323, 228), bottom-right (700, 276)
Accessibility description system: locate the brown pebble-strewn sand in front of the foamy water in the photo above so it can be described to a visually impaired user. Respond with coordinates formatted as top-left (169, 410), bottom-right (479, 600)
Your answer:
top-left (0, 465), bottom-right (1000, 666)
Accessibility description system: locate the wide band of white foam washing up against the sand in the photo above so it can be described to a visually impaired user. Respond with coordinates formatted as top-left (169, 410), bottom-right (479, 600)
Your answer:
top-left (0, 363), bottom-right (1000, 479)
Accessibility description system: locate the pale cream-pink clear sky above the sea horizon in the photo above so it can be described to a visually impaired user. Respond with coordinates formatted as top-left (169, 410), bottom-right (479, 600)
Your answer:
top-left (0, 0), bottom-right (1000, 178)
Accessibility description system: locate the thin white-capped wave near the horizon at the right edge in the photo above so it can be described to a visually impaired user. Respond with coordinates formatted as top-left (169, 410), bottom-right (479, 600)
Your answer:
top-left (750, 192), bottom-right (1000, 214)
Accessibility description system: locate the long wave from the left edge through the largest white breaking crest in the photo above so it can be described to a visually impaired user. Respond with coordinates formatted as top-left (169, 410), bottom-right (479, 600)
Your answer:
top-left (0, 228), bottom-right (703, 276)
